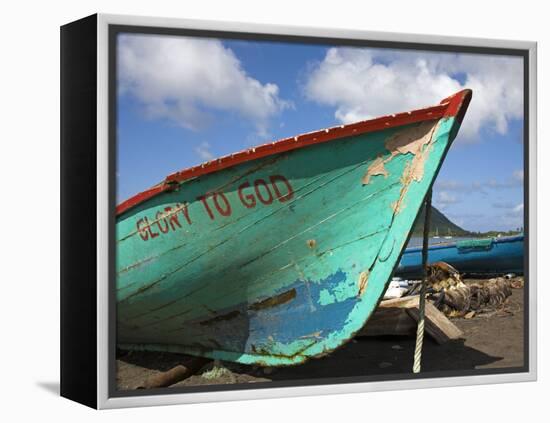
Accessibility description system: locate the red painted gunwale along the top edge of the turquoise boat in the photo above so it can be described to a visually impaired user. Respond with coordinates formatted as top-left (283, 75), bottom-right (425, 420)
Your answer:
top-left (116, 90), bottom-right (472, 216)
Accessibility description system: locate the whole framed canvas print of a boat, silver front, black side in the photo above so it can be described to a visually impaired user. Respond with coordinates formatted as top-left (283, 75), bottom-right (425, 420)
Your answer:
top-left (61, 14), bottom-right (536, 408)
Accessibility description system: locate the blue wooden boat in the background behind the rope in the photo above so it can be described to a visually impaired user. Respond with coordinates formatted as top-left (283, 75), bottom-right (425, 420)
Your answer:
top-left (396, 235), bottom-right (524, 279)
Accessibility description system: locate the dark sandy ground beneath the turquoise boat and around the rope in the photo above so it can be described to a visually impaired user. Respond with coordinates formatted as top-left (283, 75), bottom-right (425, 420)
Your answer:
top-left (117, 280), bottom-right (524, 390)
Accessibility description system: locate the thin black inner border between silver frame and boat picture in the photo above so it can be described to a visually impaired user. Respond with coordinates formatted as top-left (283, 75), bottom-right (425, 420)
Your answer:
top-left (108, 24), bottom-right (530, 398)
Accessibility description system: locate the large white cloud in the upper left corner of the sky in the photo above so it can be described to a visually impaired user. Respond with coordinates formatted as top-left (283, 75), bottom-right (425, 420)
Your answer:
top-left (118, 34), bottom-right (288, 134)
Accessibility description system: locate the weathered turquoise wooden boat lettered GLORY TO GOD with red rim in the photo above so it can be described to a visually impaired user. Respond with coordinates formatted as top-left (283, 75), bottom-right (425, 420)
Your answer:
top-left (116, 90), bottom-right (471, 366)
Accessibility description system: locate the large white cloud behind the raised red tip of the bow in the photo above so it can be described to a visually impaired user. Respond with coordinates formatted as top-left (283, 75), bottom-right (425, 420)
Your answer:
top-left (305, 48), bottom-right (523, 141)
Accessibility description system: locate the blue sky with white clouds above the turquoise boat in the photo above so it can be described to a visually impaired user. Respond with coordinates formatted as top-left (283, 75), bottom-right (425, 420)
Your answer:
top-left (117, 34), bottom-right (523, 231)
